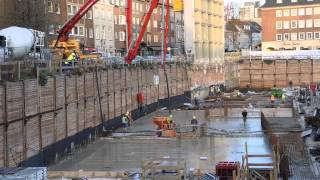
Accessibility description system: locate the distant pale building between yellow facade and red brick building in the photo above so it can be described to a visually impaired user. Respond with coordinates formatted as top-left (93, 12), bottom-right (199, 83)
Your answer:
top-left (239, 1), bottom-right (261, 24)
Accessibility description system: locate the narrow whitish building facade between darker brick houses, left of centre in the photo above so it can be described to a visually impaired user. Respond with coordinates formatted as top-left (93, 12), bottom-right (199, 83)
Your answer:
top-left (93, 0), bottom-right (115, 56)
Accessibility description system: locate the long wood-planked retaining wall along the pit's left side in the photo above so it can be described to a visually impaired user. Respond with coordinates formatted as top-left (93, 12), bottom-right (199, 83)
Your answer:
top-left (0, 66), bottom-right (195, 167)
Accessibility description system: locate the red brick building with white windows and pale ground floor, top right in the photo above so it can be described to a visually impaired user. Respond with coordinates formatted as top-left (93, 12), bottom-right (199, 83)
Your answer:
top-left (261, 0), bottom-right (320, 50)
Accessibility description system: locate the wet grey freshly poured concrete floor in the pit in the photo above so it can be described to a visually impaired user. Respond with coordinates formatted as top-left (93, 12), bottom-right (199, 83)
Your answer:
top-left (49, 110), bottom-right (272, 171)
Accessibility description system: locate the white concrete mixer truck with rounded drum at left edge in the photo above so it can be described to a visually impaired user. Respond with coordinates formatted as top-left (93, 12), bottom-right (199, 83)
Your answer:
top-left (0, 26), bottom-right (45, 61)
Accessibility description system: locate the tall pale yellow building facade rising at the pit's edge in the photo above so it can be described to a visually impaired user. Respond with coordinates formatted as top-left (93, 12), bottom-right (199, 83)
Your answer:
top-left (184, 0), bottom-right (224, 64)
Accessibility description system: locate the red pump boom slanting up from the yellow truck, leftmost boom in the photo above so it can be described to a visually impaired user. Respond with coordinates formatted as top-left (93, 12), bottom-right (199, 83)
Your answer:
top-left (55, 0), bottom-right (99, 46)
